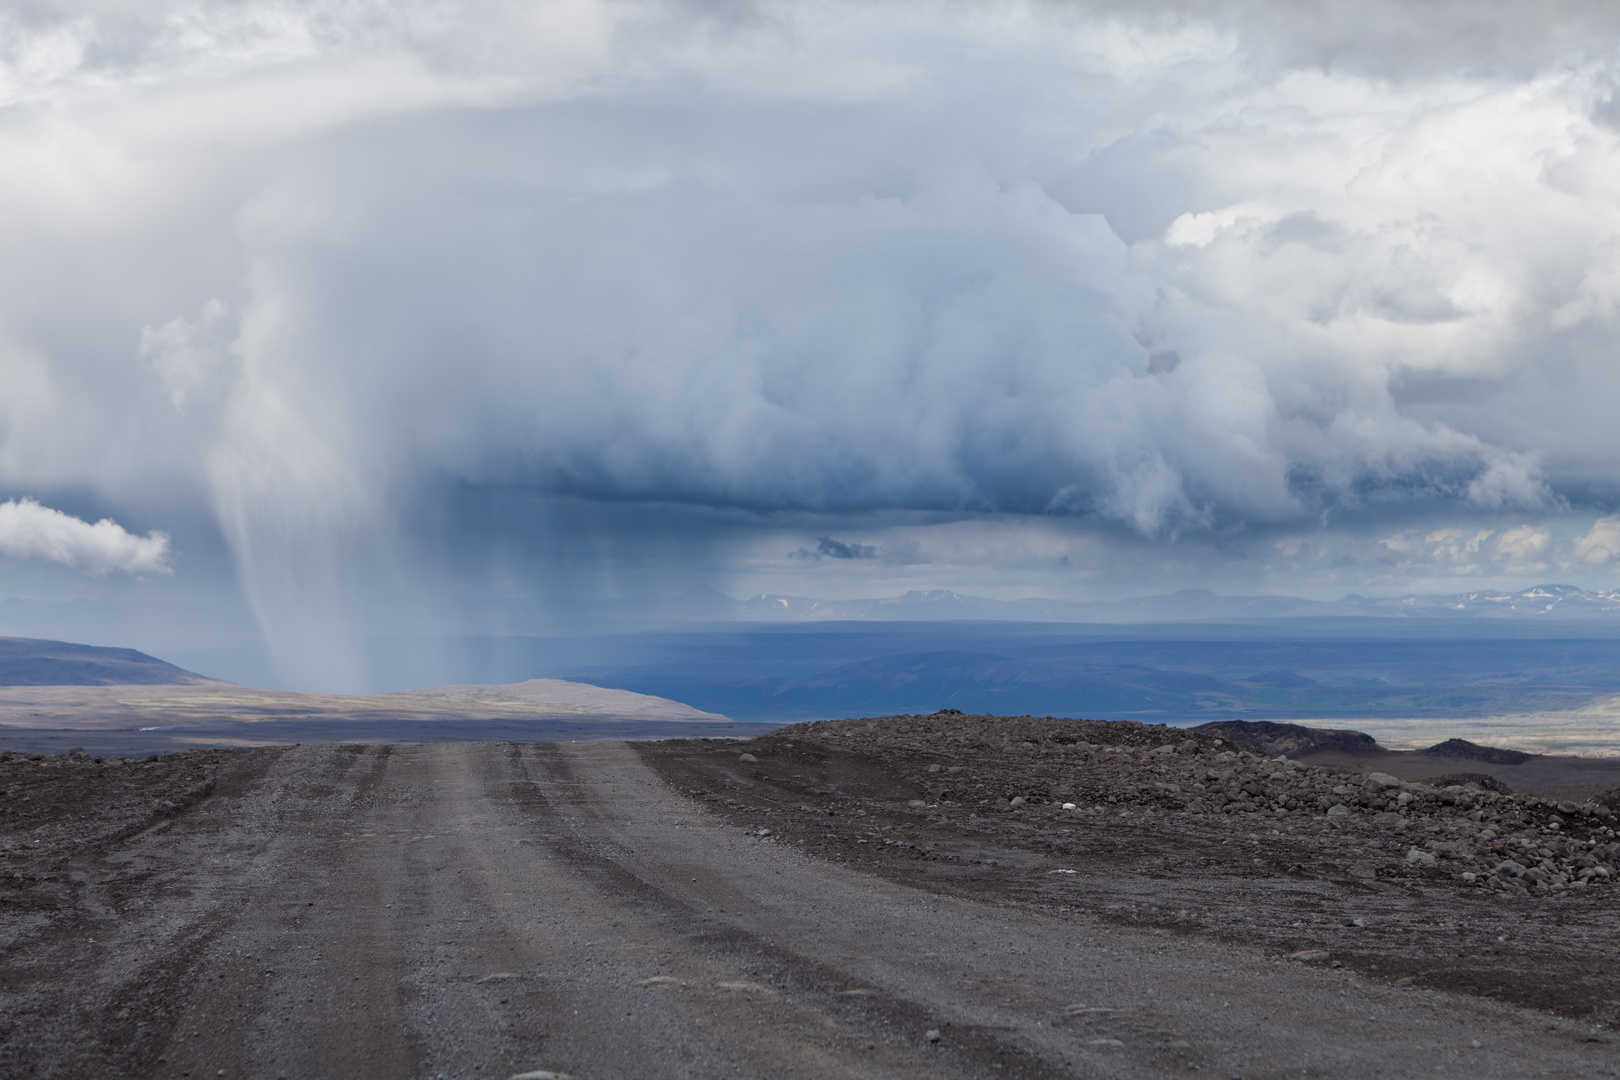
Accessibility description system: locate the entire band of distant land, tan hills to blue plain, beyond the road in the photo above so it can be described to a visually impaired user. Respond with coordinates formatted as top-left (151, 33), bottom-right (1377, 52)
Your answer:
top-left (9, 599), bottom-right (1620, 756)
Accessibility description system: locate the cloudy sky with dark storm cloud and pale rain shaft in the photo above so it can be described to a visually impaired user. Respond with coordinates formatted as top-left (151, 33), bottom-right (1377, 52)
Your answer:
top-left (0, 0), bottom-right (1620, 688)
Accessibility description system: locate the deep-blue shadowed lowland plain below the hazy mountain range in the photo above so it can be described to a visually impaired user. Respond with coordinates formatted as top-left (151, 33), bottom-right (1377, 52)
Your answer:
top-left (547, 619), bottom-right (1620, 753)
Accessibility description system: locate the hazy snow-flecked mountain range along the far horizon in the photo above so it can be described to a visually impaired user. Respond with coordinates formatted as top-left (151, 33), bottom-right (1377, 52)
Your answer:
top-left (659, 585), bottom-right (1620, 623)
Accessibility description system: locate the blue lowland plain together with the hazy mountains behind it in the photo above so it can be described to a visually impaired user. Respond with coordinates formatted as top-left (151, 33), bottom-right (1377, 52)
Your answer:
top-left (502, 585), bottom-right (1620, 753)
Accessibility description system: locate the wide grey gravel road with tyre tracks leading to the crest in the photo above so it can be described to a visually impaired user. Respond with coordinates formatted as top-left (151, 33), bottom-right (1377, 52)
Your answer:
top-left (0, 743), bottom-right (1620, 1080)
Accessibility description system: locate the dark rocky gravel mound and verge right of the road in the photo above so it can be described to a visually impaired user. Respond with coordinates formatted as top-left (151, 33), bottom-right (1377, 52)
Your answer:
top-left (640, 714), bottom-right (1620, 1030)
